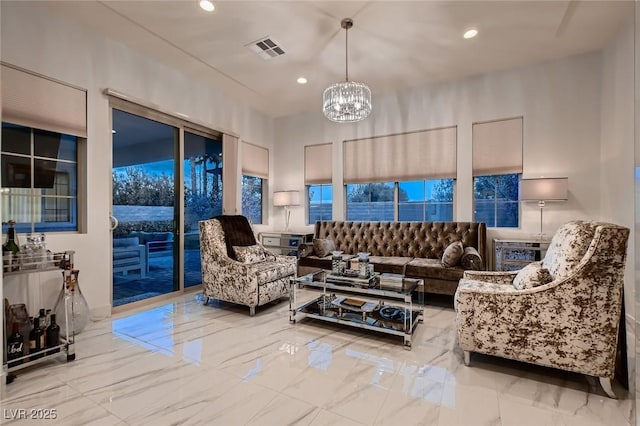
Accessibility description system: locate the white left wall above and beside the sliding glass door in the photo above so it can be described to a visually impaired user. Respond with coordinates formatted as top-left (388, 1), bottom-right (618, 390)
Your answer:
top-left (0, 2), bottom-right (274, 316)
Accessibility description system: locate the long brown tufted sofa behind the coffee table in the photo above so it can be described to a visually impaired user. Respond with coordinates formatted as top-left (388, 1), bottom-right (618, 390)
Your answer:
top-left (298, 221), bottom-right (487, 295)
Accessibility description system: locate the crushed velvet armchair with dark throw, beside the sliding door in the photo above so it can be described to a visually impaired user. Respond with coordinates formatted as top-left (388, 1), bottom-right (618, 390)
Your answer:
top-left (200, 217), bottom-right (296, 315)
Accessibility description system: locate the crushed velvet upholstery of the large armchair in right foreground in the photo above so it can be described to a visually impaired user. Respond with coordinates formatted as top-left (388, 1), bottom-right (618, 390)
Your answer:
top-left (455, 221), bottom-right (629, 381)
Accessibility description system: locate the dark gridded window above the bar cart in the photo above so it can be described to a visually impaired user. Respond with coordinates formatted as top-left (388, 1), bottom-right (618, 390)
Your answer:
top-left (1, 123), bottom-right (78, 232)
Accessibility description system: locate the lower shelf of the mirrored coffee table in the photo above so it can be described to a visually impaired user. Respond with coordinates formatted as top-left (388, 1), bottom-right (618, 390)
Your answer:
top-left (289, 297), bottom-right (422, 350)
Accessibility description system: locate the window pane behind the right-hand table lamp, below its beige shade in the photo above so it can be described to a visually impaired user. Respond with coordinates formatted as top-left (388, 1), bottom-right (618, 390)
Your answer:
top-left (473, 173), bottom-right (520, 228)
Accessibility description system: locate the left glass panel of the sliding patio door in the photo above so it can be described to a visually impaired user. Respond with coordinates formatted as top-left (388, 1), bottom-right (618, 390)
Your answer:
top-left (112, 109), bottom-right (179, 307)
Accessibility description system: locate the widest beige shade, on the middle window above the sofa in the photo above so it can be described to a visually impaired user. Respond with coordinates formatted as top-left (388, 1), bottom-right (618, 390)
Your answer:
top-left (343, 127), bottom-right (457, 183)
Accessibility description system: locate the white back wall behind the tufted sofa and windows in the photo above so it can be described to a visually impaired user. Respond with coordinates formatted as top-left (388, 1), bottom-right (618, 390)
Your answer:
top-left (273, 53), bottom-right (602, 250)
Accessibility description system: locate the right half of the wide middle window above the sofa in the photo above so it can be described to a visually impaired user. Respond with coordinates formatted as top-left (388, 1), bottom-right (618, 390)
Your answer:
top-left (398, 179), bottom-right (453, 222)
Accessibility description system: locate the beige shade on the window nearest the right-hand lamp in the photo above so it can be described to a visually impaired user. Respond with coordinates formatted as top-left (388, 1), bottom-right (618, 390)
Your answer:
top-left (473, 117), bottom-right (522, 176)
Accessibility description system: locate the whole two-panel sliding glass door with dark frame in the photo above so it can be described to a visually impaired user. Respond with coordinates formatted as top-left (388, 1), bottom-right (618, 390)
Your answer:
top-left (112, 100), bottom-right (222, 307)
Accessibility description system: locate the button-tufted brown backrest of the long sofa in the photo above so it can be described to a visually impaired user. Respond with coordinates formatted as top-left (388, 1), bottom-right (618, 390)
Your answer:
top-left (315, 221), bottom-right (487, 259)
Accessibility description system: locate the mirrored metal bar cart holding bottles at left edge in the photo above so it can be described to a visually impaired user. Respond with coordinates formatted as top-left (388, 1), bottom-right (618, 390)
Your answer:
top-left (2, 251), bottom-right (76, 384)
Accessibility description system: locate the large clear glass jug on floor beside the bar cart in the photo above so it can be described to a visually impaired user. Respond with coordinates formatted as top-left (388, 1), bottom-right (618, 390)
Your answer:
top-left (53, 270), bottom-right (89, 336)
